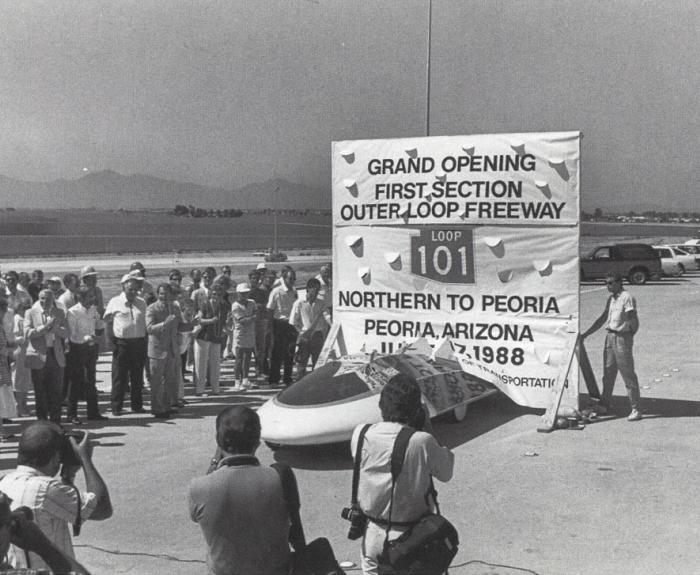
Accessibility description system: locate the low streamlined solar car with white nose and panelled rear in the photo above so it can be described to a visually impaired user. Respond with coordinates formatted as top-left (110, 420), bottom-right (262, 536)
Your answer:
top-left (258, 352), bottom-right (498, 448)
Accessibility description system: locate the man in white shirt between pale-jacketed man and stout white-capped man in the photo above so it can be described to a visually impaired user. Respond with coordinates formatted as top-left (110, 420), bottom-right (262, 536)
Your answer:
top-left (66, 286), bottom-right (107, 425)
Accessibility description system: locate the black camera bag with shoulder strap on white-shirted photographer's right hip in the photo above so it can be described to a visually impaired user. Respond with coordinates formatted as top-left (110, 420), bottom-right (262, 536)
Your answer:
top-left (377, 427), bottom-right (459, 575)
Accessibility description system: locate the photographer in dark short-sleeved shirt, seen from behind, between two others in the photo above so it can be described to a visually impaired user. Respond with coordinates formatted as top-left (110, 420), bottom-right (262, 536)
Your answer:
top-left (189, 405), bottom-right (305, 575)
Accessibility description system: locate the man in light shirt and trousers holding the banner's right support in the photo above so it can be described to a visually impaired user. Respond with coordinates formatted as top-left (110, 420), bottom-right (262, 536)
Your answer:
top-left (581, 272), bottom-right (642, 421)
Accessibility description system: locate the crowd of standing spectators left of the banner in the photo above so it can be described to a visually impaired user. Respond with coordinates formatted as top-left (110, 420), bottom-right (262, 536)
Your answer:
top-left (0, 261), bottom-right (332, 428)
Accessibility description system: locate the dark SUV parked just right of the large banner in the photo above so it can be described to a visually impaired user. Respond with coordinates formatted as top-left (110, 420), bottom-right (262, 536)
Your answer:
top-left (581, 244), bottom-right (663, 285)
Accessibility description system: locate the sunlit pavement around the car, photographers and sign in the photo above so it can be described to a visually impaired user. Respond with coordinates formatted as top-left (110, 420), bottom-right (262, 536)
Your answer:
top-left (0, 274), bottom-right (700, 575)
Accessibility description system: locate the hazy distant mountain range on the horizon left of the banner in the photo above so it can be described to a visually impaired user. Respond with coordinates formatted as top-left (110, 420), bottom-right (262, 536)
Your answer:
top-left (0, 170), bottom-right (331, 210)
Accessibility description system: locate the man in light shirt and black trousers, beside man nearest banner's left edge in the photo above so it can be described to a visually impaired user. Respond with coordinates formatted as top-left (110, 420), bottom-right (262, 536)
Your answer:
top-left (267, 268), bottom-right (299, 385)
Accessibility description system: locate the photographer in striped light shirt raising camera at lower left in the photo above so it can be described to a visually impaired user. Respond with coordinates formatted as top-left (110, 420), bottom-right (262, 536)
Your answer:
top-left (0, 421), bottom-right (112, 569)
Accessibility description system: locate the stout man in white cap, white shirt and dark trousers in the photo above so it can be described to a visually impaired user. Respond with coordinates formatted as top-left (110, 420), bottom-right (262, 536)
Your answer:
top-left (104, 274), bottom-right (147, 415)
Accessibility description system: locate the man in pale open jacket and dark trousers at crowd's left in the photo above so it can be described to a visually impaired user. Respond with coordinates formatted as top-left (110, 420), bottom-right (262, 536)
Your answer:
top-left (24, 289), bottom-right (68, 424)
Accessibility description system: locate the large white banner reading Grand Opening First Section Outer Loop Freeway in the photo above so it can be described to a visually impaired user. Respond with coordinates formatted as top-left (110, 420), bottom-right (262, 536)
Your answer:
top-left (333, 132), bottom-right (580, 407)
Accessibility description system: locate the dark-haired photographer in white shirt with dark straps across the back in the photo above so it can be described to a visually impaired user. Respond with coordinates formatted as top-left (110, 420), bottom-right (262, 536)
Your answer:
top-left (351, 374), bottom-right (454, 575)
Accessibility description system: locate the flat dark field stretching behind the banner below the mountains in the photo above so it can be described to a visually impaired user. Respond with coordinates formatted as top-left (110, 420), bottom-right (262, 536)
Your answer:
top-left (0, 209), bottom-right (698, 260)
